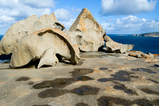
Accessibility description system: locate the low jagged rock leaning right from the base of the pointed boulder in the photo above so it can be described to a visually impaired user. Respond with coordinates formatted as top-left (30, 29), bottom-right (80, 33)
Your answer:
top-left (104, 35), bottom-right (134, 53)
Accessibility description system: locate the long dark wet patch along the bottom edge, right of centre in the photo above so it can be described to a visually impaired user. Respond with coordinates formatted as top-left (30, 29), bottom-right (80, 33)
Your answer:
top-left (97, 96), bottom-right (153, 106)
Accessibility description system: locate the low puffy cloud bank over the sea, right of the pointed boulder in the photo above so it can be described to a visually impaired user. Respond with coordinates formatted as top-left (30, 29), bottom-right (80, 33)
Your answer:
top-left (102, 15), bottom-right (159, 34)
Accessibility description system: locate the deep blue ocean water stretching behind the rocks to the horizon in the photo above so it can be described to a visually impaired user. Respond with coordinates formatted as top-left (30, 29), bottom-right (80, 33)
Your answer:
top-left (0, 34), bottom-right (159, 63)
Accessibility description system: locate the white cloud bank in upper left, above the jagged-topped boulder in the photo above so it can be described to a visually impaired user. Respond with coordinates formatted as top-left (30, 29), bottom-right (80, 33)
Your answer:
top-left (0, 0), bottom-right (55, 34)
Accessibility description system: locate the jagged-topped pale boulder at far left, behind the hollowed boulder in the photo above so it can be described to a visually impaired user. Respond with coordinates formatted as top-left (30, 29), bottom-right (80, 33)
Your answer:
top-left (0, 13), bottom-right (64, 54)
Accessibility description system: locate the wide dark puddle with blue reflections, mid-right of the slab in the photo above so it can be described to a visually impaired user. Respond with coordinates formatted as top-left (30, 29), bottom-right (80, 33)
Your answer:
top-left (98, 70), bottom-right (138, 82)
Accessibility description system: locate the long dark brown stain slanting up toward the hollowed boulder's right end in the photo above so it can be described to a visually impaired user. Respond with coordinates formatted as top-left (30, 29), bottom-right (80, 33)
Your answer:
top-left (33, 68), bottom-right (94, 89)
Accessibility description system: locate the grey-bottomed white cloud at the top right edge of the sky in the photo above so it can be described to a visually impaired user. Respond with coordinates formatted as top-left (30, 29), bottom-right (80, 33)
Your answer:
top-left (101, 0), bottom-right (157, 15)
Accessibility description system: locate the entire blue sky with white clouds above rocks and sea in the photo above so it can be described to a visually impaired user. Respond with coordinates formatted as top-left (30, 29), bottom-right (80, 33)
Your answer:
top-left (0, 0), bottom-right (159, 35)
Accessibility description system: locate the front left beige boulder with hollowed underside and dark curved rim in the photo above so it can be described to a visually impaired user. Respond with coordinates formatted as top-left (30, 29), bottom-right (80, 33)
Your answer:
top-left (10, 28), bottom-right (79, 68)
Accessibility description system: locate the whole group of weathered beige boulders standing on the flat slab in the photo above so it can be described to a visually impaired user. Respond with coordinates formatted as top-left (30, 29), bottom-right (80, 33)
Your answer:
top-left (0, 8), bottom-right (133, 68)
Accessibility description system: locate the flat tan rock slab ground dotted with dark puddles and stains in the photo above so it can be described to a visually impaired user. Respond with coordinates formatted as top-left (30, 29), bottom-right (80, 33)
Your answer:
top-left (0, 52), bottom-right (159, 106)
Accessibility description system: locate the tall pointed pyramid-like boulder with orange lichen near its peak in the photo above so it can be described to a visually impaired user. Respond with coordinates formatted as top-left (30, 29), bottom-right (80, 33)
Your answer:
top-left (65, 8), bottom-right (106, 51)
